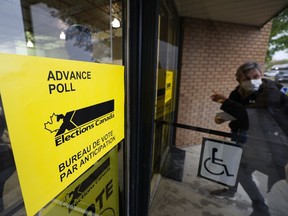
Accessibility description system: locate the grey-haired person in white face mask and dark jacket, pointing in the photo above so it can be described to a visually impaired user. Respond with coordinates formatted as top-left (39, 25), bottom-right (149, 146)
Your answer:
top-left (211, 62), bottom-right (288, 216)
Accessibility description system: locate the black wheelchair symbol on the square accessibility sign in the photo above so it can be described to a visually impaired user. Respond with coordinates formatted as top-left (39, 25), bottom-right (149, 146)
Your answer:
top-left (204, 148), bottom-right (234, 176)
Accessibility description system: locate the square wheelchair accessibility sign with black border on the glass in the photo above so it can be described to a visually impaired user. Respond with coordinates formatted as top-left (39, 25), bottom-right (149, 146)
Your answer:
top-left (198, 138), bottom-right (242, 186)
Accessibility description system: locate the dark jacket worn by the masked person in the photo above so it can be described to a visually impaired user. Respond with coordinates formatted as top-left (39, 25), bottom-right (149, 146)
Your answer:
top-left (221, 79), bottom-right (288, 191)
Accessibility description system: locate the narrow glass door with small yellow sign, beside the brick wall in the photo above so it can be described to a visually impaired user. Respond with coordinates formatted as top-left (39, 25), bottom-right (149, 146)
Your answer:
top-left (153, 0), bottom-right (178, 178)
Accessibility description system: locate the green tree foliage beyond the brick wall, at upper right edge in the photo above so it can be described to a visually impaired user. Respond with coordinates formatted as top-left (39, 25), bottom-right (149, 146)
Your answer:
top-left (266, 7), bottom-right (288, 62)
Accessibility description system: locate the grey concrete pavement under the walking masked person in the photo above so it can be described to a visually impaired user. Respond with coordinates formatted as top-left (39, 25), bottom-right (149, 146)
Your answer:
top-left (149, 145), bottom-right (288, 216)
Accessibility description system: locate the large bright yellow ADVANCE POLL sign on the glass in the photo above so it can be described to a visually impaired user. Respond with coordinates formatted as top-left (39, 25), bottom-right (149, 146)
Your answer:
top-left (0, 54), bottom-right (124, 215)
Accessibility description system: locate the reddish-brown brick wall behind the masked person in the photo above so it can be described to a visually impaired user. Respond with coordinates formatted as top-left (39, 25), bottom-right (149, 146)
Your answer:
top-left (176, 18), bottom-right (271, 146)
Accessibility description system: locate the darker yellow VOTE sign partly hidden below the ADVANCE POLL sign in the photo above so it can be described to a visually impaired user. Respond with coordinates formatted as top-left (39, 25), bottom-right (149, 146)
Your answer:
top-left (40, 147), bottom-right (119, 216)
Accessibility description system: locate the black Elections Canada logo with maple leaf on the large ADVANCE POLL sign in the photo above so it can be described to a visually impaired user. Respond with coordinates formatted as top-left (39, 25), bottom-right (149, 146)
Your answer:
top-left (44, 100), bottom-right (115, 146)
